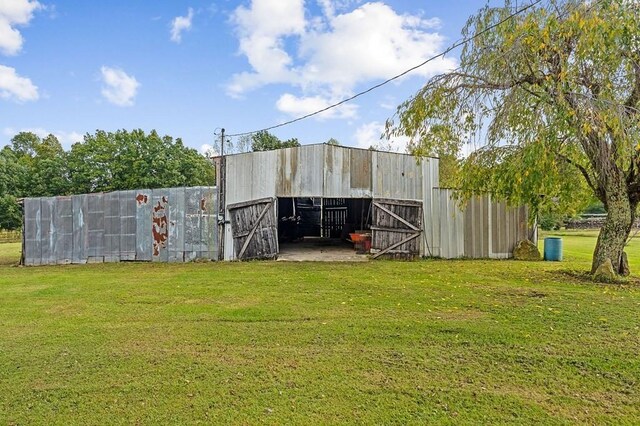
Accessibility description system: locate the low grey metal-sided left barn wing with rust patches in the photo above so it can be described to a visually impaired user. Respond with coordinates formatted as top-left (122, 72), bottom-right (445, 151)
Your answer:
top-left (23, 187), bottom-right (218, 265)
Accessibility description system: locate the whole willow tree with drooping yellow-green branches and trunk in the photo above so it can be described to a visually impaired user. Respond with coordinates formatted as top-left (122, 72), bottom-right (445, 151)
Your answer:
top-left (387, 0), bottom-right (640, 273)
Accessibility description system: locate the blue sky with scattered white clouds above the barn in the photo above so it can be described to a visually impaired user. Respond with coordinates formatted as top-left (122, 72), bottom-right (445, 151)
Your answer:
top-left (0, 0), bottom-right (498, 152)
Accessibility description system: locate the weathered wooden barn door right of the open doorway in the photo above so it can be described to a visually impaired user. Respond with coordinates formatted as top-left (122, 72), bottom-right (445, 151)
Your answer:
top-left (371, 199), bottom-right (422, 259)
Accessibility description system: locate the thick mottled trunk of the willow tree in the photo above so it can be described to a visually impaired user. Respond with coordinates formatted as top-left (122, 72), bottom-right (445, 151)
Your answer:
top-left (591, 184), bottom-right (636, 274)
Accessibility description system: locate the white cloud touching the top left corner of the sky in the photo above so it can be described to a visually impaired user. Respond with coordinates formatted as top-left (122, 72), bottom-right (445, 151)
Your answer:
top-left (0, 0), bottom-right (42, 55)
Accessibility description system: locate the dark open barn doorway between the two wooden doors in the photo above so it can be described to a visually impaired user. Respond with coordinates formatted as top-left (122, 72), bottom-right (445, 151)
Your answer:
top-left (278, 197), bottom-right (372, 261)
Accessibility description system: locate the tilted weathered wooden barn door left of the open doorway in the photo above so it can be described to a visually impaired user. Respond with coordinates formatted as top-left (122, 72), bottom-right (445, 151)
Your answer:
top-left (228, 198), bottom-right (278, 260)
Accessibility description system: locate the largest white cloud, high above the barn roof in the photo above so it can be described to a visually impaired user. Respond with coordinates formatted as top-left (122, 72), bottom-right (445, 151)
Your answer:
top-left (227, 0), bottom-right (456, 118)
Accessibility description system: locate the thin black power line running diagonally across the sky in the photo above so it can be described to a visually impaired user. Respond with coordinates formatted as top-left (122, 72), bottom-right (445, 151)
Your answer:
top-left (228, 0), bottom-right (542, 137)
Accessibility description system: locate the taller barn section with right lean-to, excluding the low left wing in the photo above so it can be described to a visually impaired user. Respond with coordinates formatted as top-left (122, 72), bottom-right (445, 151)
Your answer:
top-left (216, 144), bottom-right (529, 260)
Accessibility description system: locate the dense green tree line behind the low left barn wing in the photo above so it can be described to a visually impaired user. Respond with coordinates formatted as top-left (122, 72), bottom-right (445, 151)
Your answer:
top-left (0, 129), bottom-right (215, 229)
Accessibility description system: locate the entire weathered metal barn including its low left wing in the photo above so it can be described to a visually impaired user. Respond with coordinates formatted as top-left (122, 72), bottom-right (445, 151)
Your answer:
top-left (18, 144), bottom-right (532, 265)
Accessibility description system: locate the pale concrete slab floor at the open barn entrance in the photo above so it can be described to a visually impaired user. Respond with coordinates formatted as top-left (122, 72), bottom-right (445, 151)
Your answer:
top-left (278, 237), bottom-right (369, 262)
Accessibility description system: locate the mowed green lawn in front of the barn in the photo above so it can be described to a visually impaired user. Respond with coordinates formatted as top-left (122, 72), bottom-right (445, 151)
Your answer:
top-left (0, 232), bottom-right (640, 425)
